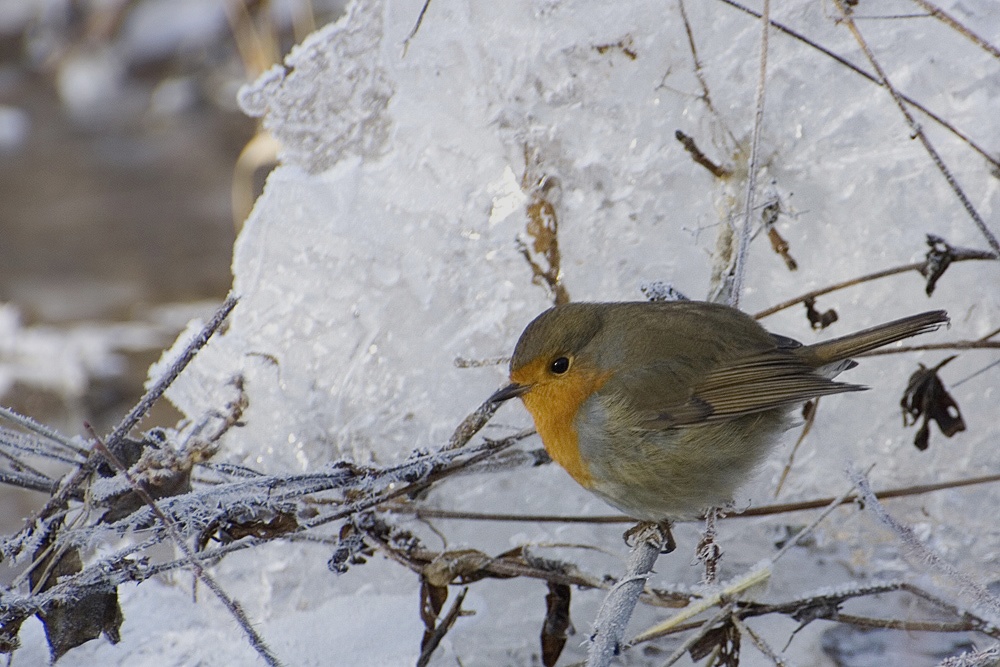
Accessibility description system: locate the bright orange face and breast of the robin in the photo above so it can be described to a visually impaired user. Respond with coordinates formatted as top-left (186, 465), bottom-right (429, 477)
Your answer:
top-left (511, 362), bottom-right (611, 488)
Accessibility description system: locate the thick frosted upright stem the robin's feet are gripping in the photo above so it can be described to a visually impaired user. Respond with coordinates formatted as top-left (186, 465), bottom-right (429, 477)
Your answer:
top-left (587, 524), bottom-right (666, 667)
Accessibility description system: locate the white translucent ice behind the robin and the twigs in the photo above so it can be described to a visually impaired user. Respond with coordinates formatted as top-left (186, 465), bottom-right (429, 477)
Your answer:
top-left (31, 0), bottom-right (1000, 666)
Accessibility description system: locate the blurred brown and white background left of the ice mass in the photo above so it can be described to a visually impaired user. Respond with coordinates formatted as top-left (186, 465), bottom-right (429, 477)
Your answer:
top-left (0, 0), bottom-right (345, 530)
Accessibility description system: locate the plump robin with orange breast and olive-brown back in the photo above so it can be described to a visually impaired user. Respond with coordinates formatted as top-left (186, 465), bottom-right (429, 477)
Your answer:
top-left (490, 301), bottom-right (948, 526)
